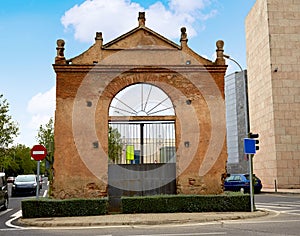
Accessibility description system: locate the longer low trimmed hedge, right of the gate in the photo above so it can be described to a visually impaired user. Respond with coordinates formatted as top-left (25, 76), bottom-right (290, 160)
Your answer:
top-left (121, 194), bottom-right (251, 213)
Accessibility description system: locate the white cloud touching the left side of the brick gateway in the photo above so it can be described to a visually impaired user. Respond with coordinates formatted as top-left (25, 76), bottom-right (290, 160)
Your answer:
top-left (27, 86), bottom-right (55, 130)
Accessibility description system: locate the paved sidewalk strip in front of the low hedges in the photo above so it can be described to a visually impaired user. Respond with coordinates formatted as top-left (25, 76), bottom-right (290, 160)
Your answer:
top-left (18, 210), bottom-right (269, 227)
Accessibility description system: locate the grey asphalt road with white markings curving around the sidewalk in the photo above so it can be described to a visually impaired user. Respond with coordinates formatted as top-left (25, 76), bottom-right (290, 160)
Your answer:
top-left (0, 194), bottom-right (300, 236)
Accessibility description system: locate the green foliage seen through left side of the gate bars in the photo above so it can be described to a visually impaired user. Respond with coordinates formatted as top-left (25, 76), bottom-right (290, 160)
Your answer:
top-left (108, 127), bottom-right (123, 162)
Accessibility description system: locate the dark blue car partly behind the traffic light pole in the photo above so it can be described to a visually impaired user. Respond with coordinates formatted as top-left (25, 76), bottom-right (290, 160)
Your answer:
top-left (224, 174), bottom-right (262, 193)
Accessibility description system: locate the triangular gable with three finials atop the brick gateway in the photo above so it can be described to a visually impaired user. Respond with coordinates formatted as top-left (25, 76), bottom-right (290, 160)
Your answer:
top-left (68, 12), bottom-right (218, 65)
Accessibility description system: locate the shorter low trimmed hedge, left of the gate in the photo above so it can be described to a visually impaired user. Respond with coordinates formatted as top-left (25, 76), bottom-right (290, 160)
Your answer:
top-left (21, 198), bottom-right (108, 218)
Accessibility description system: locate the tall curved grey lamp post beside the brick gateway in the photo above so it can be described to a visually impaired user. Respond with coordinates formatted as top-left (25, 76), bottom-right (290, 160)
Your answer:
top-left (223, 54), bottom-right (254, 212)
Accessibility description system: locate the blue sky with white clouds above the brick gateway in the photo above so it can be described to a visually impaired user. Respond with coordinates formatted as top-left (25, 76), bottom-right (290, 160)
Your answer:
top-left (0, 0), bottom-right (255, 147)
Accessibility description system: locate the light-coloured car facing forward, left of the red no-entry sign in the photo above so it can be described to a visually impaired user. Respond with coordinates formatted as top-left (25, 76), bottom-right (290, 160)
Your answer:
top-left (11, 175), bottom-right (39, 196)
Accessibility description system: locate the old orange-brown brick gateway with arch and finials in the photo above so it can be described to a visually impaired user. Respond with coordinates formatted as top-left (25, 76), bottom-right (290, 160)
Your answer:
top-left (53, 12), bottom-right (227, 199)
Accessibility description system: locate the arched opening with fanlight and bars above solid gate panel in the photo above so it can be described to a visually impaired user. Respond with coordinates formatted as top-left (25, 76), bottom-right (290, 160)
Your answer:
top-left (108, 83), bottom-right (176, 164)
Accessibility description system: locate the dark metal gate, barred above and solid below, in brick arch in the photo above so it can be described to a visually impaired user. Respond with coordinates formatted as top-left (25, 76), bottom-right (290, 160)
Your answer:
top-left (108, 120), bottom-right (176, 211)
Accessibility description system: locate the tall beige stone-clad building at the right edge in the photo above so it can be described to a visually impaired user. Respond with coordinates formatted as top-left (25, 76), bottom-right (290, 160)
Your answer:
top-left (246, 0), bottom-right (300, 188)
